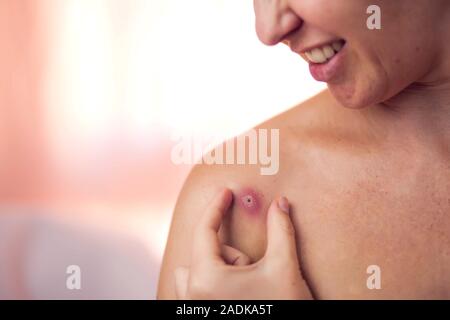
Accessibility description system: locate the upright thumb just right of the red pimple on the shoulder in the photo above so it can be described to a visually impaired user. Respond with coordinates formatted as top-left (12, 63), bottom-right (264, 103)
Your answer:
top-left (265, 197), bottom-right (298, 266)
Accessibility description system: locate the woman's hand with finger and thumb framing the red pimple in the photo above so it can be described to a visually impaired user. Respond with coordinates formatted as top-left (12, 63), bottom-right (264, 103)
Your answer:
top-left (175, 189), bottom-right (312, 300)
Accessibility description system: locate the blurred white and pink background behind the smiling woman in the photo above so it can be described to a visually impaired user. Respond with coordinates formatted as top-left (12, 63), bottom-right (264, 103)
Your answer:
top-left (0, 0), bottom-right (324, 298)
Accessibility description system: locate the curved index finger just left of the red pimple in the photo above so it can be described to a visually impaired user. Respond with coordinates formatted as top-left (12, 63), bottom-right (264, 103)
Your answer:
top-left (192, 189), bottom-right (233, 263)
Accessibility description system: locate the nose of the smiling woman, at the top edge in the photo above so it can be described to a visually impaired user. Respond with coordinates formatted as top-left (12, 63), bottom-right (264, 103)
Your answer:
top-left (253, 0), bottom-right (303, 46)
